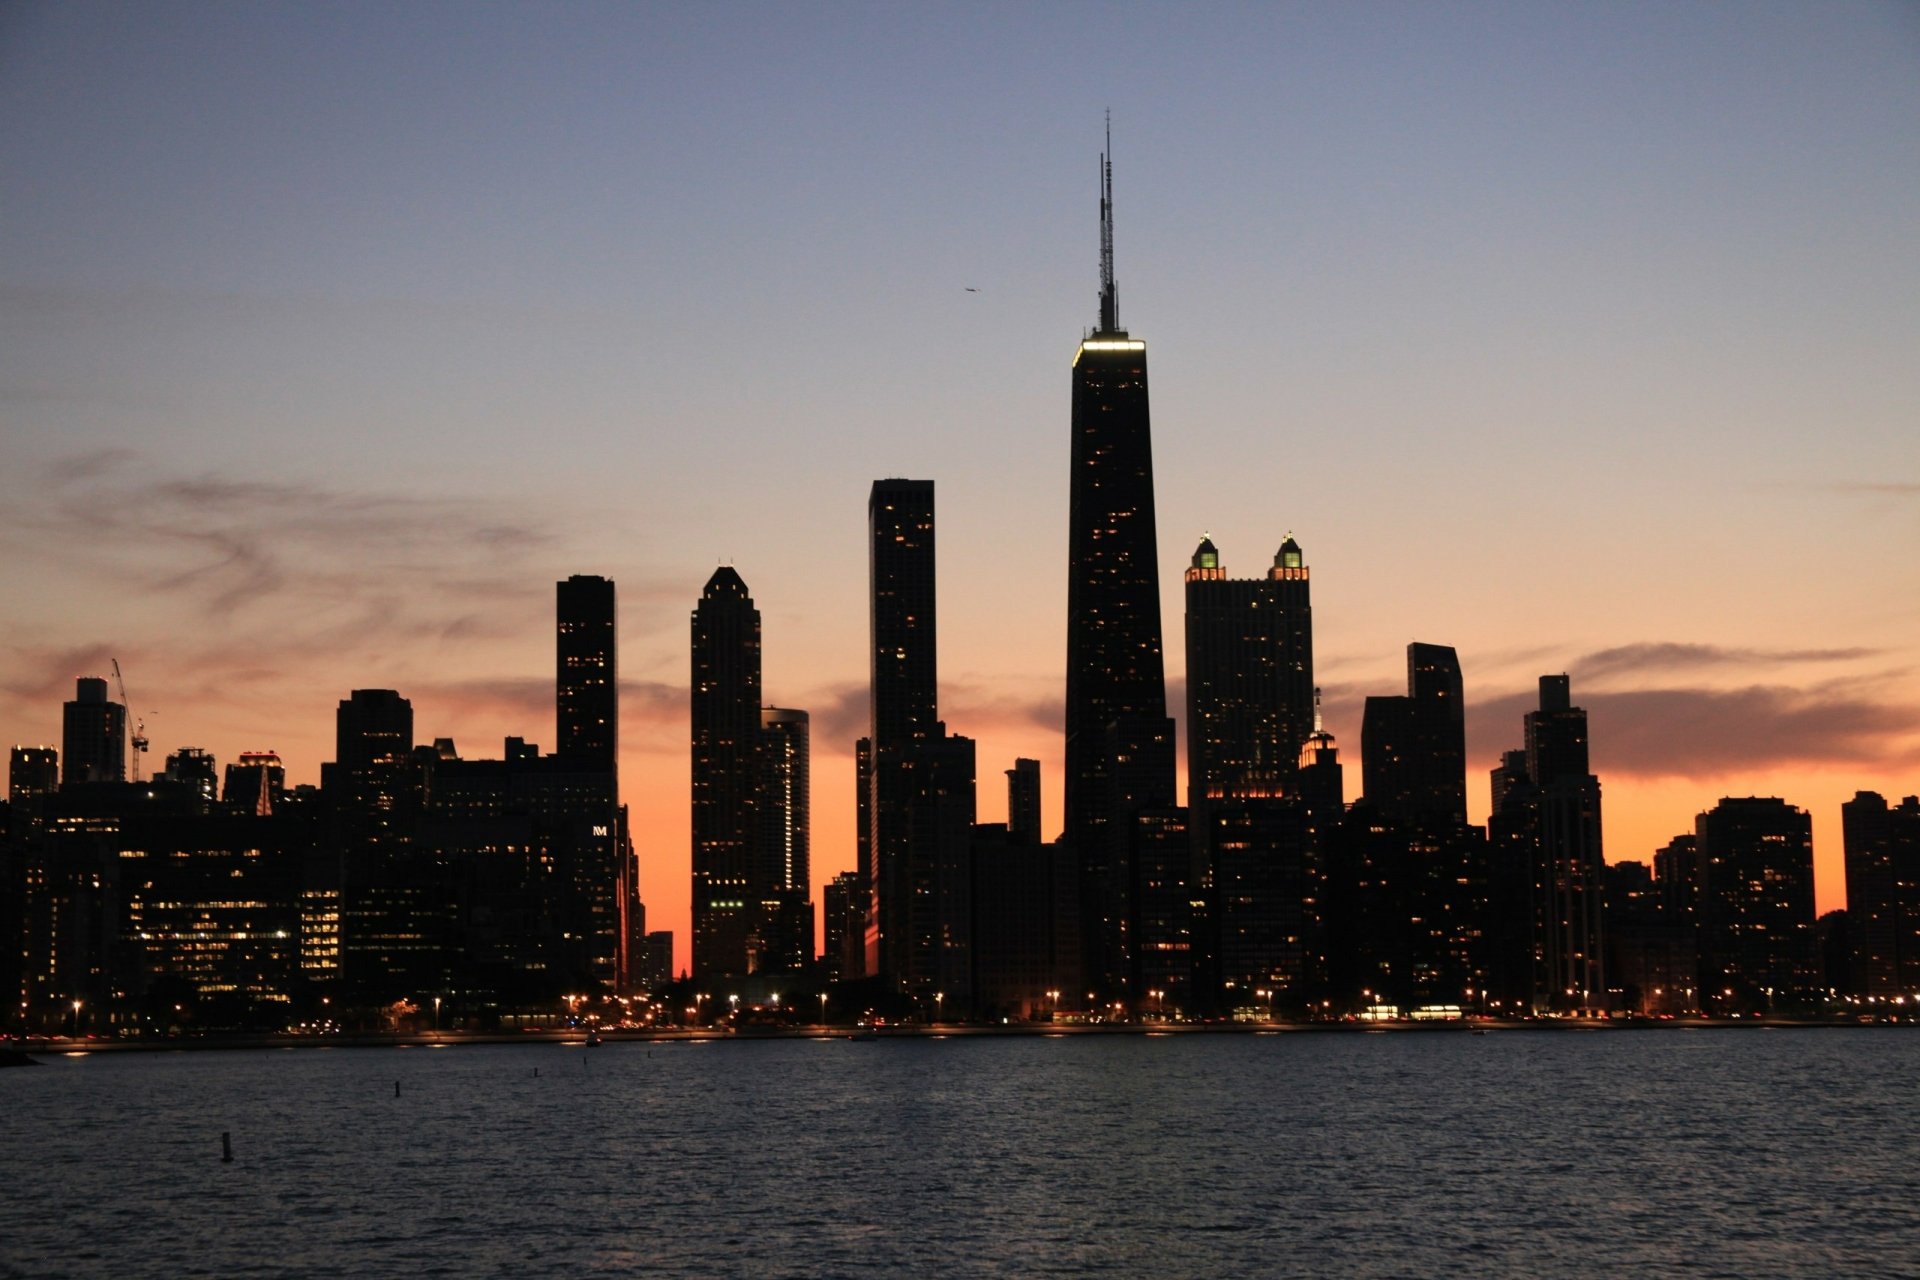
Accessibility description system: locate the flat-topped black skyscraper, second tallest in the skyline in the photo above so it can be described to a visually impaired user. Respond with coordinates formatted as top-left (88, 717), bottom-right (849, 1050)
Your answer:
top-left (866, 480), bottom-right (945, 983)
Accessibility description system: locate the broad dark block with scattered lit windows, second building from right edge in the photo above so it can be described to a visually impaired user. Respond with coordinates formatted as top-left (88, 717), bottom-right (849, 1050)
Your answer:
top-left (1693, 796), bottom-right (1818, 1013)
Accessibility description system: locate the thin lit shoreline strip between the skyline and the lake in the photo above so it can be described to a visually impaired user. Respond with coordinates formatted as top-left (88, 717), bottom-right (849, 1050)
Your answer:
top-left (11, 1017), bottom-right (1908, 1057)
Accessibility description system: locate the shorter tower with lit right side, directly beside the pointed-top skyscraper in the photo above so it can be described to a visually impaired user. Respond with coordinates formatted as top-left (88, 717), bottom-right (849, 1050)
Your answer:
top-left (753, 706), bottom-right (814, 973)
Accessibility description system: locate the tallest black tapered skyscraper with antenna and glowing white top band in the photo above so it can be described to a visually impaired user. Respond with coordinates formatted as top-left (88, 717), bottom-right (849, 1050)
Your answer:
top-left (1066, 130), bottom-right (1175, 990)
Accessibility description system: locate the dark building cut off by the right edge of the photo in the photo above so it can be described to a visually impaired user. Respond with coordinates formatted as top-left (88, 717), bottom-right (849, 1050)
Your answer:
top-left (1839, 791), bottom-right (1920, 1002)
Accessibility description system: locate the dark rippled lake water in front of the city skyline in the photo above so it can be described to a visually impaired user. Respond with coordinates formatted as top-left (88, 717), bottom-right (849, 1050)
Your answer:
top-left (0, 1029), bottom-right (1920, 1278)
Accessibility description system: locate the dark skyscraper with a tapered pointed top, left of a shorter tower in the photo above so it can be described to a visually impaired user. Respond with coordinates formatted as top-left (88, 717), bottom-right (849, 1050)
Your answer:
top-left (693, 568), bottom-right (762, 975)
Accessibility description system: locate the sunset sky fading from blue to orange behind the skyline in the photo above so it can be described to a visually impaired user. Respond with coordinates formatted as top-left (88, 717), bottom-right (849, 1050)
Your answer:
top-left (0, 0), bottom-right (1920, 965)
